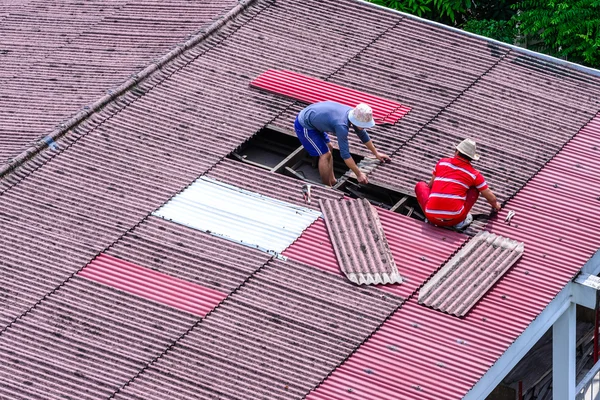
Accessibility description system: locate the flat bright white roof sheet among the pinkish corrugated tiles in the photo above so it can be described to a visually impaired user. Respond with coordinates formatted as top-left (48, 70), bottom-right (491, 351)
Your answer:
top-left (153, 176), bottom-right (321, 254)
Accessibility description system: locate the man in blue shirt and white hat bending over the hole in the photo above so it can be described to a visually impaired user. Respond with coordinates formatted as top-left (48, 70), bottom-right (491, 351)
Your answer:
top-left (294, 101), bottom-right (390, 186)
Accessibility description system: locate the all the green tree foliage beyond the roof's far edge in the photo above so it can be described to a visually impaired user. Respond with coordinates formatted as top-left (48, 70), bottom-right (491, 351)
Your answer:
top-left (369, 0), bottom-right (600, 67)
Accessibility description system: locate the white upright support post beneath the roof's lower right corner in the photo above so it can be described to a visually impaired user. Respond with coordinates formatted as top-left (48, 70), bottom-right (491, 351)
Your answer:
top-left (552, 303), bottom-right (577, 400)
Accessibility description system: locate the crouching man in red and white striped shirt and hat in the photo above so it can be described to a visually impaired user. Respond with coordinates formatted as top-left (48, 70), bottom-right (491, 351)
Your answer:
top-left (415, 139), bottom-right (501, 230)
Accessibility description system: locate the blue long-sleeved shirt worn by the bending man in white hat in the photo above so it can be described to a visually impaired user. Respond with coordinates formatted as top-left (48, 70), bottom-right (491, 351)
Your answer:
top-left (298, 101), bottom-right (371, 160)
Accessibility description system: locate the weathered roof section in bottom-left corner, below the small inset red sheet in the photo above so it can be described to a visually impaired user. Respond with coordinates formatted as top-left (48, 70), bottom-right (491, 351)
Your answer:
top-left (0, 276), bottom-right (199, 400)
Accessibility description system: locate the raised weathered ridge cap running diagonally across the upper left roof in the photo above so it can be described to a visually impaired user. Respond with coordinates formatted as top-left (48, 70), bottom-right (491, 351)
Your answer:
top-left (0, 0), bottom-right (256, 179)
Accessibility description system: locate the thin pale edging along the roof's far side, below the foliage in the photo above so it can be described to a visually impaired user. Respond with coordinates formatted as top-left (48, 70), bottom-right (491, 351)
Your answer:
top-left (352, 0), bottom-right (600, 77)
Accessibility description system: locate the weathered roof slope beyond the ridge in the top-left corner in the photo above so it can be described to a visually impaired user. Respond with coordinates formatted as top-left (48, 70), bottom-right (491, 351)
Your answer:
top-left (0, 0), bottom-right (237, 163)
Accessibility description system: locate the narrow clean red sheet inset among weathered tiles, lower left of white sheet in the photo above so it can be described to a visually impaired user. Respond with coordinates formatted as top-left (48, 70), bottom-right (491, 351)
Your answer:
top-left (78, 254), bottom-right (227, 317)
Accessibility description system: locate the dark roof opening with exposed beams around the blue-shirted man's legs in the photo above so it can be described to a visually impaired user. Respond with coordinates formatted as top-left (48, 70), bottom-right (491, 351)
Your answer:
top-left (228, 125), bottom-right (364, 184)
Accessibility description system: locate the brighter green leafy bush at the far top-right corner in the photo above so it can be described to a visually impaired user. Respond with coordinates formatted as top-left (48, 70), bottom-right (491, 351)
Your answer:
top-left (513, 0), bottom-right (600, 67)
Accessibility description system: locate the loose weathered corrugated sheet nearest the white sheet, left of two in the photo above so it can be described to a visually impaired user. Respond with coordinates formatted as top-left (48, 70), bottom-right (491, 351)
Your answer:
top-left (319, 199), bottom-right (402, 285)
